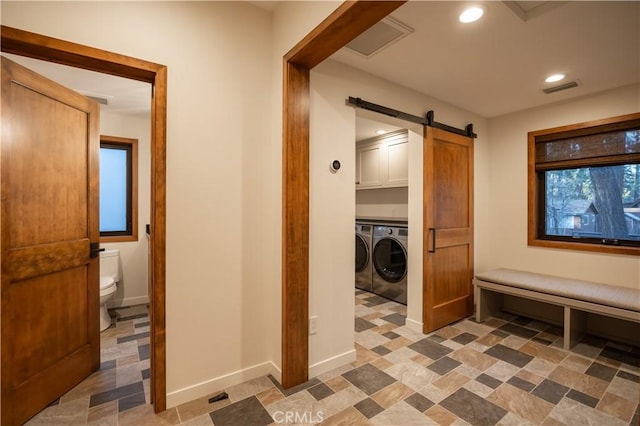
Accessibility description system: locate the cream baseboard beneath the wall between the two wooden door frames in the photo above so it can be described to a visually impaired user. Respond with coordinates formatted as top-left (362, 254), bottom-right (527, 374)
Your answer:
top-left (167, 361), bottom-right (281, 408)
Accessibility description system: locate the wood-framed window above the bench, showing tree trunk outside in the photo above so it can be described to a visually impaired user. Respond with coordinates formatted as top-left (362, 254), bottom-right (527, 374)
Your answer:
top-left (528, 113), bottom-right (640, 255)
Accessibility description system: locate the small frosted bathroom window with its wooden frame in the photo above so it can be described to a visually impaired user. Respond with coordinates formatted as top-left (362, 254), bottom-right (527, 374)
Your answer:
top-left (100, 136), bottom-right (138, 242)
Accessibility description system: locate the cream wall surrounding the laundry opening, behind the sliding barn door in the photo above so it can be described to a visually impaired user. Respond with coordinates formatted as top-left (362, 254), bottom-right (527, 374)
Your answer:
top-left (309, 60), bottom-right (488, 352)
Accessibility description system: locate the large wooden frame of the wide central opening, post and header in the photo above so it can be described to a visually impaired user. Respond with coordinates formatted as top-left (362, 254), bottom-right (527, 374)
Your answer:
top-left (281, 1), bottom-right (406, 388)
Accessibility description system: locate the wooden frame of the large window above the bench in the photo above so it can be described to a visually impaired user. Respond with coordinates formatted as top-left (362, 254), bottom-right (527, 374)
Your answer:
top-left (527, 113), bottom-right (640, 256)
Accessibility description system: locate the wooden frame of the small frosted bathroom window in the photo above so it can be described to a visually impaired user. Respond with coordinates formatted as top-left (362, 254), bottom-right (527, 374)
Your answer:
top-left (100, 135), bottom-right (138, 243)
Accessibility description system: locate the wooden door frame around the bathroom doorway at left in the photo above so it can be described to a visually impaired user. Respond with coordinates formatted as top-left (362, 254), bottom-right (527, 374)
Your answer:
top-left (0, 25), bottom-right (167, 413)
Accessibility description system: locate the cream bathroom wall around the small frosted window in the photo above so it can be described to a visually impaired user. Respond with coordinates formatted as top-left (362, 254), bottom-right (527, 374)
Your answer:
top-left (100, 111), bottom-right (151, 307)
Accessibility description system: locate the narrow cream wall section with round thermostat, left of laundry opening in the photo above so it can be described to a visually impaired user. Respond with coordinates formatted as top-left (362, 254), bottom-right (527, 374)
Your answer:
top-left (309, 71), bottom-right (356, 376)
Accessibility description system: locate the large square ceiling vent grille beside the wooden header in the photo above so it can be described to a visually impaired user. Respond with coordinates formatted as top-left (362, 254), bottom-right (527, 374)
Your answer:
top-left (346, 16), bottom-right (414, 58)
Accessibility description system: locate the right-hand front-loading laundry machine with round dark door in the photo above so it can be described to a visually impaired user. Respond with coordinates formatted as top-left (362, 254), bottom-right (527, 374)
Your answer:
top-left (371, 225), bottom-right (409, 305)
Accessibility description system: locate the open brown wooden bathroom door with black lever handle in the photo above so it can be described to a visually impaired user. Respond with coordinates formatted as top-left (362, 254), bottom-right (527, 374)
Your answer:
top-left (0, 57), bottom-right (100, 425)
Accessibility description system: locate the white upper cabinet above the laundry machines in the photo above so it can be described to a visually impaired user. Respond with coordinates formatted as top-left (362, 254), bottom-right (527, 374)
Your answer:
top-left (356, 130), bottom-right (409, 189)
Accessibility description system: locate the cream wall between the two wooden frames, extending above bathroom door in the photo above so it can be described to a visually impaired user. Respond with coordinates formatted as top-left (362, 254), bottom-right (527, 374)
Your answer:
top-left (1, 1), bottom-right (278, 406)
